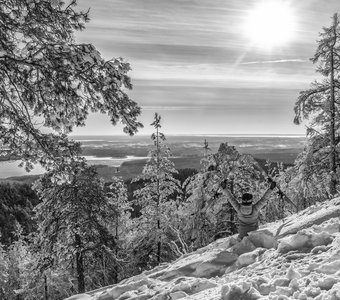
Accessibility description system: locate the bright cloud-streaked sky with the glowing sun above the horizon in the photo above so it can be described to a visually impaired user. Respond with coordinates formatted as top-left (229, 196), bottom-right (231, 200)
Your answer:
top-left (74, 0), bottom-right (340, 135)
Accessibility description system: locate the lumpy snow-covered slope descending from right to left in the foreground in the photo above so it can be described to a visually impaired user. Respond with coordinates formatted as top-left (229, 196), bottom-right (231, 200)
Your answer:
top-left (68, 198), bottom-right (340, 300)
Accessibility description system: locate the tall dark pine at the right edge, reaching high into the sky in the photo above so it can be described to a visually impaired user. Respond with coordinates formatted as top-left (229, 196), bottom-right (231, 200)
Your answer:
top-left (294, 14), bottom-right (340, 196)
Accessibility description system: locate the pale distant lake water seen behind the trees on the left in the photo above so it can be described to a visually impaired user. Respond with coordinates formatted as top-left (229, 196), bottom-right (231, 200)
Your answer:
top-left (0, 155), bottom-right (147, 179)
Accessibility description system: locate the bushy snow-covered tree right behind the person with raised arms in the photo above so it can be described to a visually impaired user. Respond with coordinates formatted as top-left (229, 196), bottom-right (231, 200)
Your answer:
top-left (184, 143), bottom-right (264, 248)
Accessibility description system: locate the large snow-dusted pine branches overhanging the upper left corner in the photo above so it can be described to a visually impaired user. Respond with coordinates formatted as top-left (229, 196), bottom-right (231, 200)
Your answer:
top-left (0, 0), bottom-right (141, 169)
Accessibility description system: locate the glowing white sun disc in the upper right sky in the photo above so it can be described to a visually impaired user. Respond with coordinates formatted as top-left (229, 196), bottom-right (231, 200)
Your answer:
top-left (244, 0), bottom-right (295, 49)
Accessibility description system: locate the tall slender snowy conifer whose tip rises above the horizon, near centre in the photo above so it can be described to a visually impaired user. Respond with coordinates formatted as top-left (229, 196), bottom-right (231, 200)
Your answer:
top-left (134, 113), bottom-right (180, 267)
